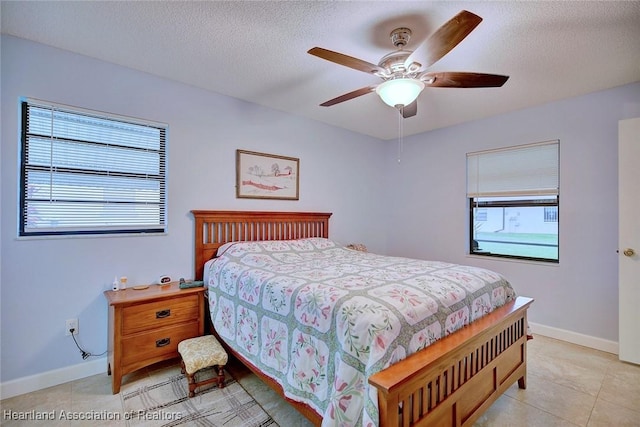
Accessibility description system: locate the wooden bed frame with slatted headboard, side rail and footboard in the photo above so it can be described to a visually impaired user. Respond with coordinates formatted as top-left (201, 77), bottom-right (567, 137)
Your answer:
top-left (192, 210), bottom-right (533, 427)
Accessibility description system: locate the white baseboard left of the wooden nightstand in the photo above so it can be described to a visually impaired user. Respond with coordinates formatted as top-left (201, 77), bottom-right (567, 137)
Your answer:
top-left (0, 357), bottom-right (107, 399)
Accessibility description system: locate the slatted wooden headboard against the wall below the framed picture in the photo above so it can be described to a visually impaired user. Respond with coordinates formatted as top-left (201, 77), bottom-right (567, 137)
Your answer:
top-left (191, 210), bottom-right (331, 280)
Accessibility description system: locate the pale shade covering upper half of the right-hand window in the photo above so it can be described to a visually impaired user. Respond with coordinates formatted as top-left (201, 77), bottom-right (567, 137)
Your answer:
top-left (467, 140), bottom-right (559, 198)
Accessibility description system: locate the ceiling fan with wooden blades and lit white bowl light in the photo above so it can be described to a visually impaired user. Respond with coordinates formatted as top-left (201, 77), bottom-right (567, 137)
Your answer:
top-left (308, 10), bottom-right (509, 118)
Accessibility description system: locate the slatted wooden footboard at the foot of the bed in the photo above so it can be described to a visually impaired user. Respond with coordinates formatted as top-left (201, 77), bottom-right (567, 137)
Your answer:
top-left (369, 297), bottom-right (533, 427)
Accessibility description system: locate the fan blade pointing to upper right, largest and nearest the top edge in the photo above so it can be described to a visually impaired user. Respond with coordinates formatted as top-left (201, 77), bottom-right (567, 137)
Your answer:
top-left (404, 10), bottom-right (482, 68)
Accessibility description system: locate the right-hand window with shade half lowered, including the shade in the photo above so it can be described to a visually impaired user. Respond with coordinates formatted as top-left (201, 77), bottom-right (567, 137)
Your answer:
top-left (467, 141), bottom-right (559, 262)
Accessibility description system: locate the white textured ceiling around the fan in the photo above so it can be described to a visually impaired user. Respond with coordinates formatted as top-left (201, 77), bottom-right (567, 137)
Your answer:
top-left (1, 1), bottom-right (640, 140)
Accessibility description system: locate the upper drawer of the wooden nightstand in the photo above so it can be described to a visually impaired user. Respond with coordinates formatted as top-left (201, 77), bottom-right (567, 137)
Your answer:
top-left (122, 295), bottom-right (200, 335)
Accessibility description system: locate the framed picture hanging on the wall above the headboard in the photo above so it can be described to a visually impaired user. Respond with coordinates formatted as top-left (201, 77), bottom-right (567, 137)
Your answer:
top-left (236, 150), bottom-right (300, 200)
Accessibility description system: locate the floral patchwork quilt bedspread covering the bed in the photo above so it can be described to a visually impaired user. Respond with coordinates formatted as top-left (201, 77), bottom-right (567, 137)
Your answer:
top-left (205, 238), bottom-right (515, 426)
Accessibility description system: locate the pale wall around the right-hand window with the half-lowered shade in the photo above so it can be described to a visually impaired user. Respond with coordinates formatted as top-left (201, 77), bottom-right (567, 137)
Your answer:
top-left (387, 83), bottom-right (640, 342)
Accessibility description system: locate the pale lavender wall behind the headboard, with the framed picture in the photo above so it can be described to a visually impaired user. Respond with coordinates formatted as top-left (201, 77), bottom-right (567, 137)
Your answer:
top-left (0, 35), bottom-right (385, 383)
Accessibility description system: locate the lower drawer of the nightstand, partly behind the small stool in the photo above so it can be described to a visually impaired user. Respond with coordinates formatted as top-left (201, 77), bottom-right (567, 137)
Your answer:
top-left (122, 320), bottom-right (200, 366)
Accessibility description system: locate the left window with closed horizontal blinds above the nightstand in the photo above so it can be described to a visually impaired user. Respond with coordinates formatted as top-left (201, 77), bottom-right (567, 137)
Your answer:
top-left (19, 99), bottom-right (167, 236)
